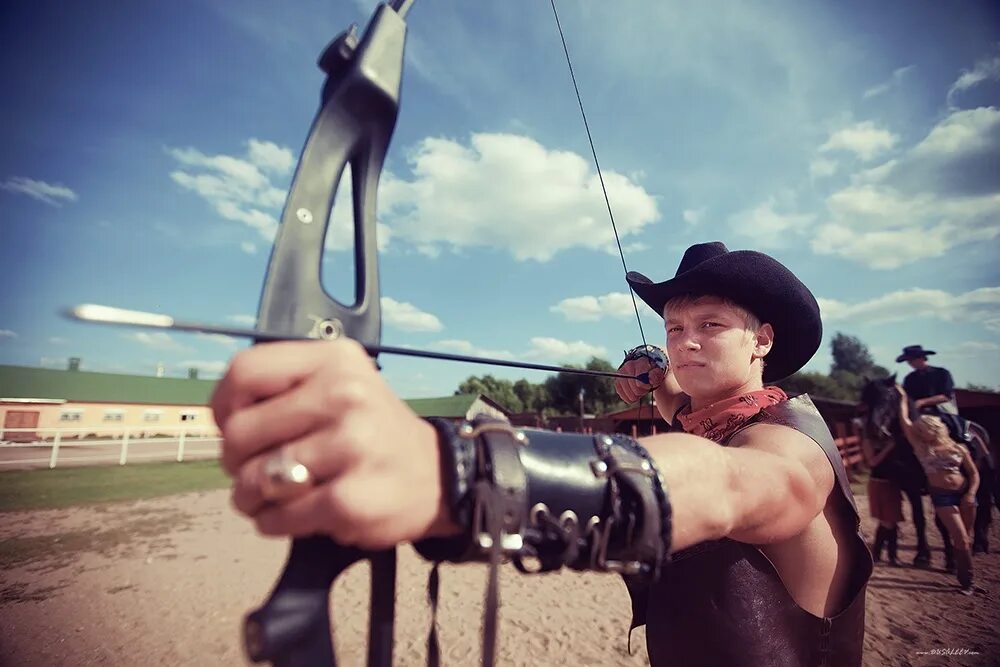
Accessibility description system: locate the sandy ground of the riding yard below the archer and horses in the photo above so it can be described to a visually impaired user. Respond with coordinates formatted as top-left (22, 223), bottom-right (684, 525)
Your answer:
top-left (0, 491), bottom-right (1000, 667)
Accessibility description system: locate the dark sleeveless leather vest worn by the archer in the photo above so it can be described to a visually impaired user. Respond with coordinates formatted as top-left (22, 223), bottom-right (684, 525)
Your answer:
top-left (626, 395), bottom-right (872, 667)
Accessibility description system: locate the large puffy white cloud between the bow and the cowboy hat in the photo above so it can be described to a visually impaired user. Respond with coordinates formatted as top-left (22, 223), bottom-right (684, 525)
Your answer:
top-left (380, 134), bottom-right (659, 262)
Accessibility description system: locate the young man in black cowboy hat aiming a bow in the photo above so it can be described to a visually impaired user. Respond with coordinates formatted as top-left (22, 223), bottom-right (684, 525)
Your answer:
top-left (212, 243), bottom-right (872, 667)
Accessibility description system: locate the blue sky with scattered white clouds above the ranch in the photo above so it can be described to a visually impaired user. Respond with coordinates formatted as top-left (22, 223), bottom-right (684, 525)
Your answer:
top-left (0, 0), bottom-right (1000, 397)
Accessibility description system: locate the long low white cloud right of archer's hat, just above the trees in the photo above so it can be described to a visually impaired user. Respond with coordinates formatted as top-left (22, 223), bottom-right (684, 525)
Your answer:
top-left (817, 287), bottom-right (1000, 332)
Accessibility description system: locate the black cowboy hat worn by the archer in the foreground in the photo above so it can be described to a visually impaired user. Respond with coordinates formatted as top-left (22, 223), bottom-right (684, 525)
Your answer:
top-left (626, 241), bottom-right (823, 382)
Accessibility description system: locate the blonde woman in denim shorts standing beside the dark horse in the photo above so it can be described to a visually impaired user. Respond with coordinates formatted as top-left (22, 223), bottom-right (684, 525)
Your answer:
top-left (896, 385), bottom-right (979, 595)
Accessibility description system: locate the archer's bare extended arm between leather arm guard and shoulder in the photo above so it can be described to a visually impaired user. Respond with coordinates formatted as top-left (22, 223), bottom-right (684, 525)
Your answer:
top-left (641, 434), bottom-right (822, 551)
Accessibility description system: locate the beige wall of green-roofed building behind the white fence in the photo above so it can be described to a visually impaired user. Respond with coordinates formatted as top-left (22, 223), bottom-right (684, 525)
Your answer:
top-left (0, 401), bottom-right (219, 440)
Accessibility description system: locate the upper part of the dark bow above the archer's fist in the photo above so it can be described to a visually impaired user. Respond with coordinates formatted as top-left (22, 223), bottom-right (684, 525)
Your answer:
top-left (257, 6), bottom-right (406, 345)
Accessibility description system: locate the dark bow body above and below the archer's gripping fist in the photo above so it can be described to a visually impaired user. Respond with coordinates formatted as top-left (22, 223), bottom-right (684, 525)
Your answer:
top-left (244, 0), bottom-right (412, 667)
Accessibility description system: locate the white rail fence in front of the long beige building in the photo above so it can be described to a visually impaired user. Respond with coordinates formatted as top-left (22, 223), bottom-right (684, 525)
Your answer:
top-left (0, 426), bottom-right (222, 470)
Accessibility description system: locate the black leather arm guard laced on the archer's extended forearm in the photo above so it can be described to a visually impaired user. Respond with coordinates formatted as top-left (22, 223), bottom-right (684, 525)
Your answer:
top-left (415, 418), bottom-right (671, 579)
